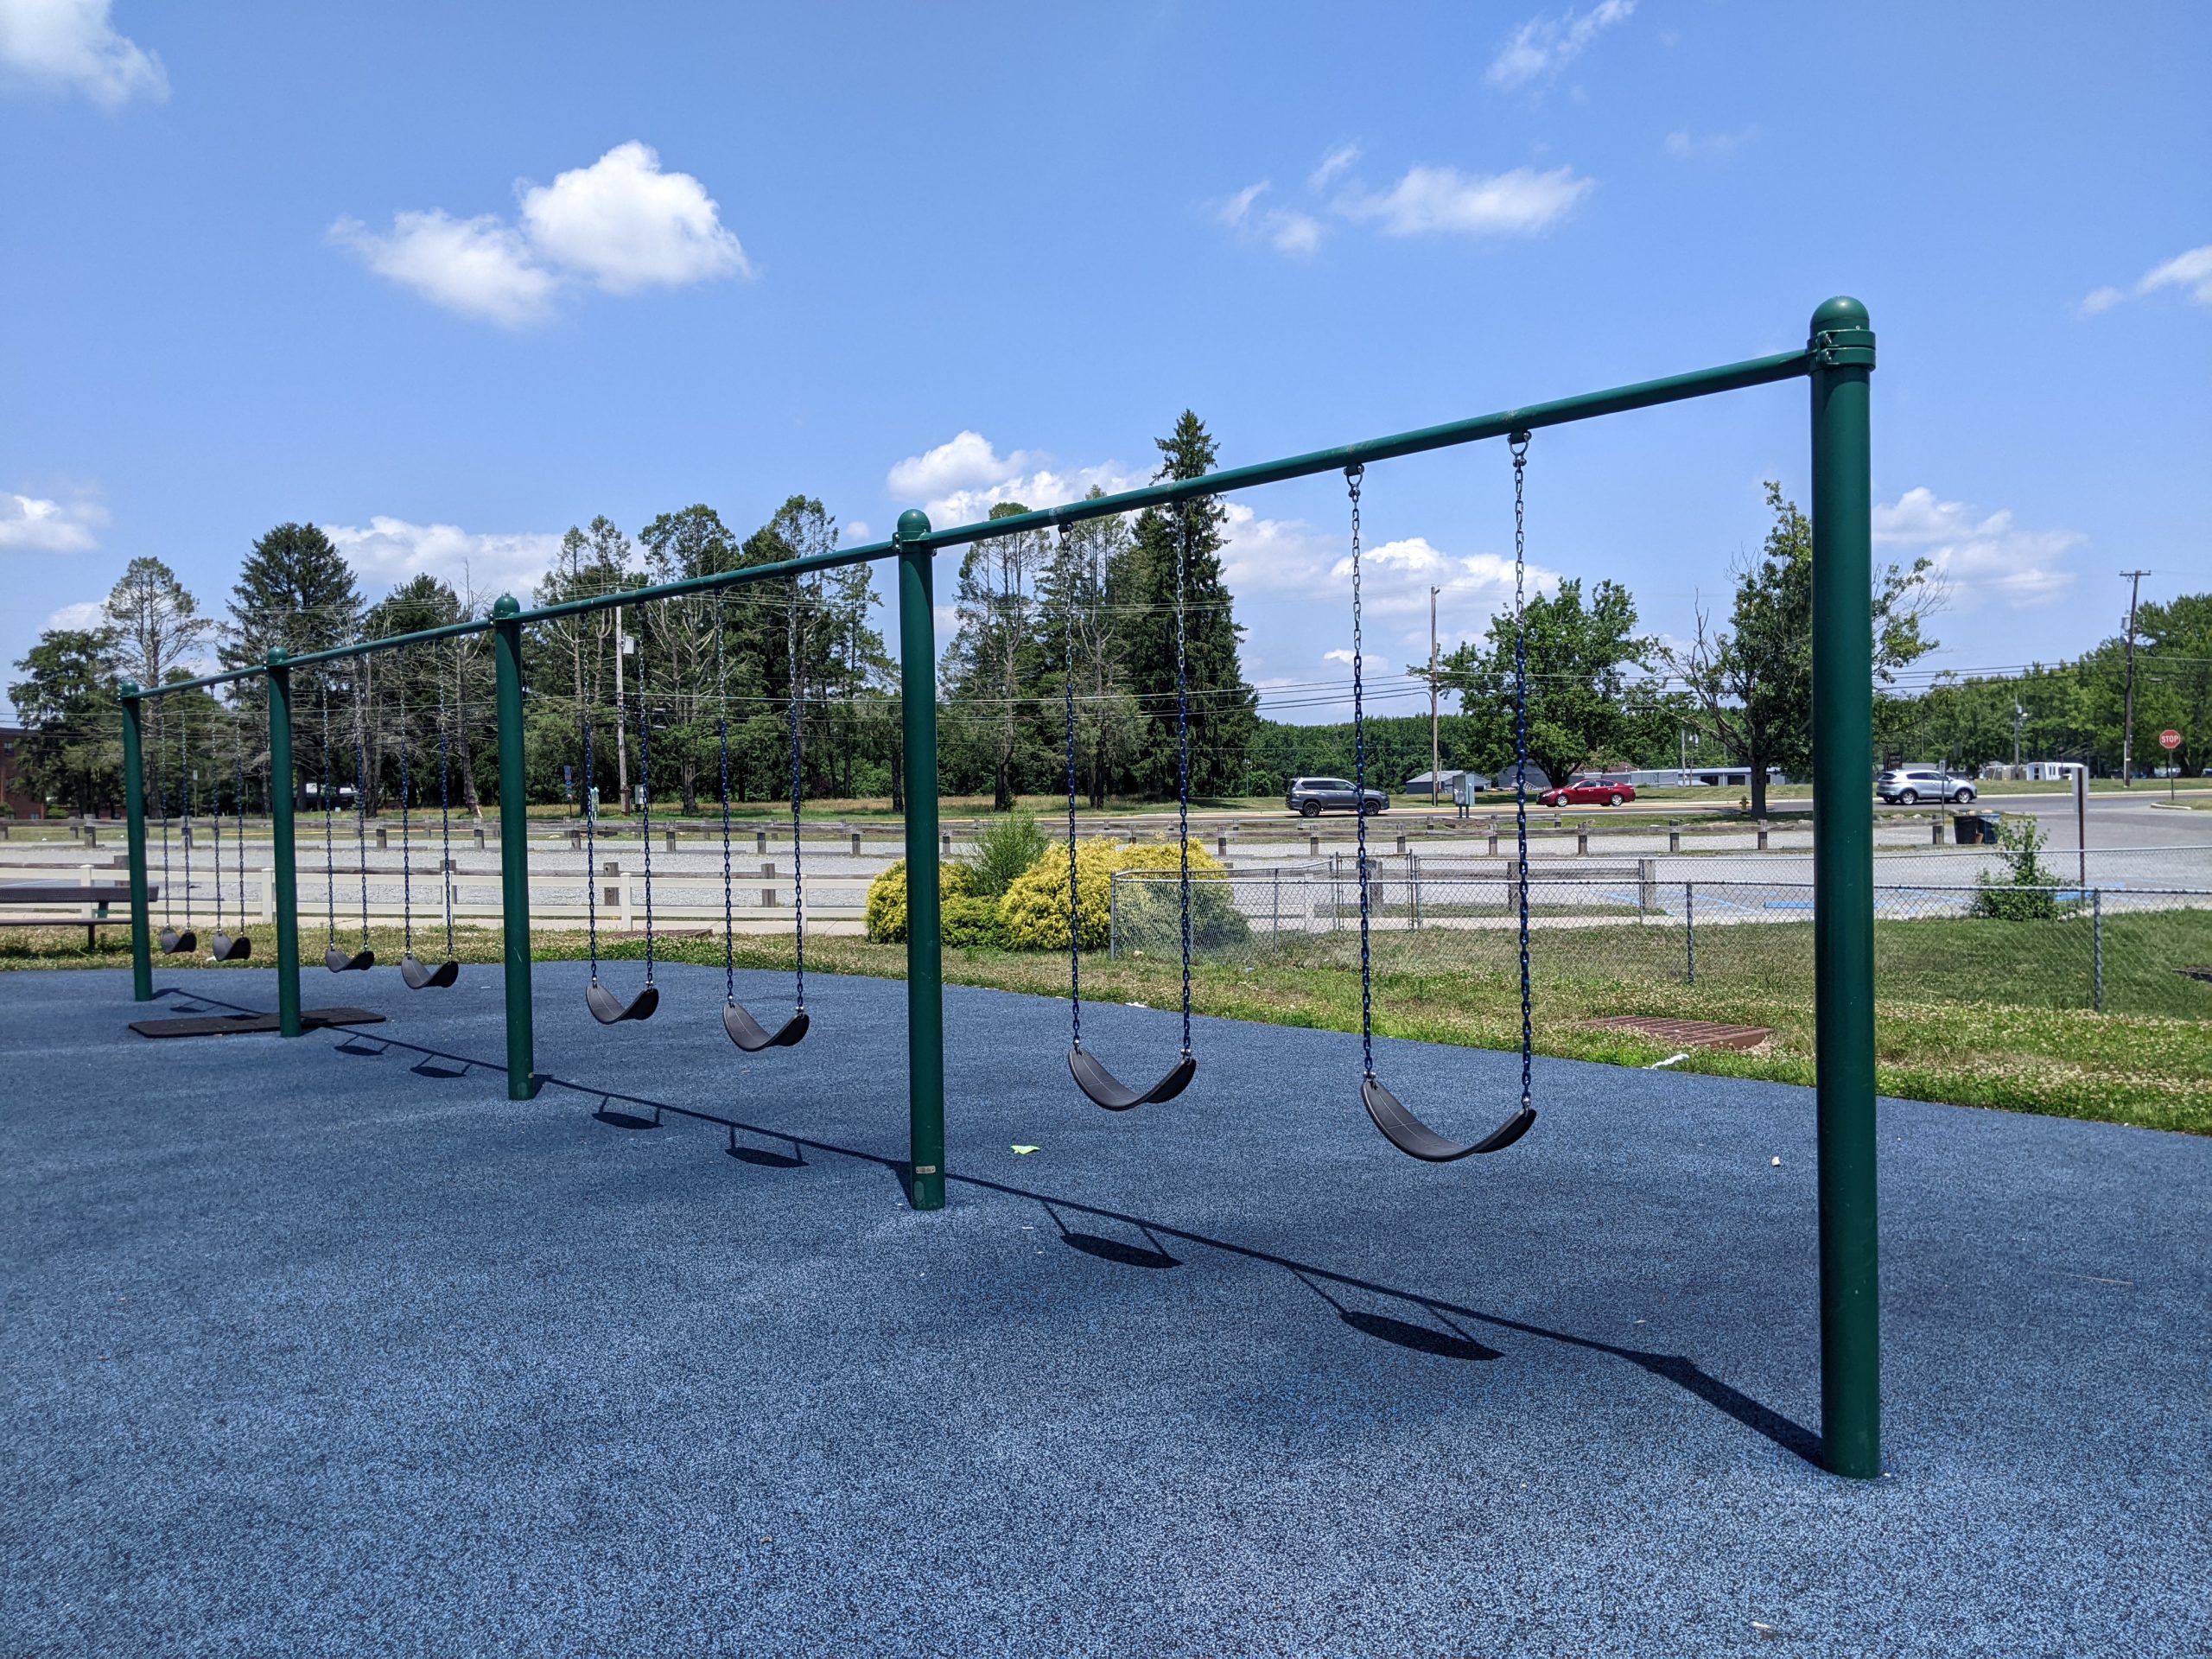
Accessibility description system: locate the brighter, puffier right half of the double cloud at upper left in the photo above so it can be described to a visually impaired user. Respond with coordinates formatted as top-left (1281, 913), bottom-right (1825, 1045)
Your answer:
top-left (522, 139), bottom-right (752, 294)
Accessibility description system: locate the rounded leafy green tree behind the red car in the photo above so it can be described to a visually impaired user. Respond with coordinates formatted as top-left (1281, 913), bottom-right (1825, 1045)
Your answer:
top-left (1418, 577), bottom-right (1656, 800)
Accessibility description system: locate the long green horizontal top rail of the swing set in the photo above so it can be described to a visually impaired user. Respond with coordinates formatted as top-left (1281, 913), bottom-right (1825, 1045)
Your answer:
top-left (122, 329), bottom-right (1814, 702)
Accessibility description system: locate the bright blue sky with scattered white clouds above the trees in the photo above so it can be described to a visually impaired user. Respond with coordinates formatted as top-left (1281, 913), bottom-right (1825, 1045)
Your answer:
top-left (0, 0), bottom-right (2212, 719)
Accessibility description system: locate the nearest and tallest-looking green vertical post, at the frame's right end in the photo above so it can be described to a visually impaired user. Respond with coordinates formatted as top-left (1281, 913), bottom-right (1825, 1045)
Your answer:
top-left (1808, 299), bottom-right (1883, 1480)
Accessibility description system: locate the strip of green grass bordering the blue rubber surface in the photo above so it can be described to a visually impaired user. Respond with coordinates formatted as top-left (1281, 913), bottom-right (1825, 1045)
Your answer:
top-left (0, 912), bottom-right (2212, 1135)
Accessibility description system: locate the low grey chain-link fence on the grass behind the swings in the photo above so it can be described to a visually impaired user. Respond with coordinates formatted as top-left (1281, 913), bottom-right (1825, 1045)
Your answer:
top-left (1110, 858), bottom-right (2212, 1018)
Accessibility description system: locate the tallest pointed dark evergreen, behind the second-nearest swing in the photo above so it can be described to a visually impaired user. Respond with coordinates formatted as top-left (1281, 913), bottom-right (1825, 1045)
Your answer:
top-left (1109, 410), bottom-right (1259, 797)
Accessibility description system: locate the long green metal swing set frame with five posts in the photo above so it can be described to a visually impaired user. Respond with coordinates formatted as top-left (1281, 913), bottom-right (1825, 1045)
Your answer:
top-left (107, 296), bottom-right (1883, 1478)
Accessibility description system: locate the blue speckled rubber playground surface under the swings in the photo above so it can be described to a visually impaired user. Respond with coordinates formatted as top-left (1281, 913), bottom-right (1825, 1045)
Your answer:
top-left (0, 964), bottom-right (2212, 1659)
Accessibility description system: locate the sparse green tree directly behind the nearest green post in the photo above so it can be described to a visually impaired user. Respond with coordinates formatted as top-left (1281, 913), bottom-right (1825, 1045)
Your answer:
top-left (1672, 480), bottom-right (1942, 817)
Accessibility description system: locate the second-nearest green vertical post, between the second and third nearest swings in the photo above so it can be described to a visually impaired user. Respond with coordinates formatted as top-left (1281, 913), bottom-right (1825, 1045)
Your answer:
top-left (898, 511), bottom-right (944, 1210)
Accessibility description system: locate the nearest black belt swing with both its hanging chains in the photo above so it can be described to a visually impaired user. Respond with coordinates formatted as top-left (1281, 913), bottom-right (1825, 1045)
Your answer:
top-left (1344, 448), bottom-right (1535, 1164)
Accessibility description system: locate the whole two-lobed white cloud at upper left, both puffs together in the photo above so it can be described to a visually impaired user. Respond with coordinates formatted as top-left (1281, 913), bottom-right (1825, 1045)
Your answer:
top-left (329, 139), bottom-right (752, 327)
